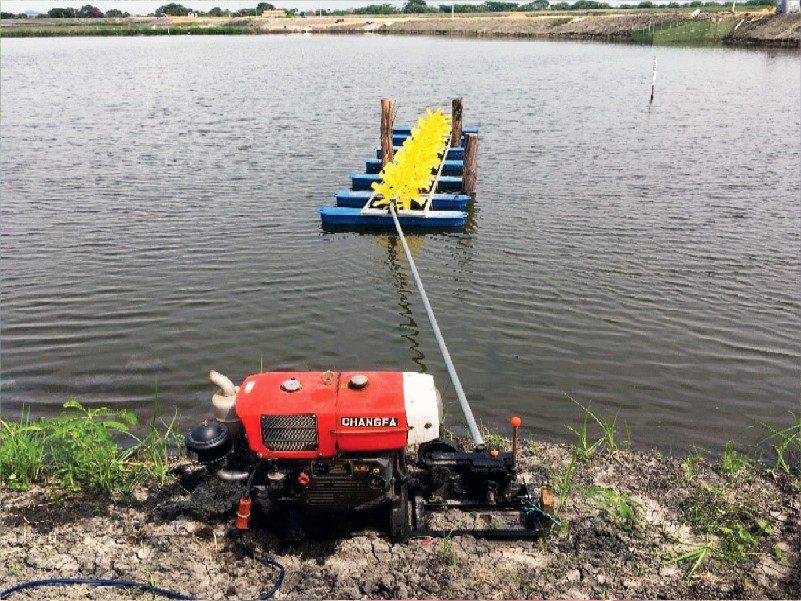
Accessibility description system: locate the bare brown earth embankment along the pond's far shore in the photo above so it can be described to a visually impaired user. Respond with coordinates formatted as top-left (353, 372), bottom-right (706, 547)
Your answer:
top-left (0, 9), bottom-right (801, 48)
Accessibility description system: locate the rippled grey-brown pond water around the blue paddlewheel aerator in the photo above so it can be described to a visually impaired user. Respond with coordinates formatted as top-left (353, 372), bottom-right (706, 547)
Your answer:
top-left (0, 35), bottom-right (801, 449)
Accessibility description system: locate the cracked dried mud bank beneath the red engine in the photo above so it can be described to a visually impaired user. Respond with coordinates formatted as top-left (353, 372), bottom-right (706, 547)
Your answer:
top-left (0, 442), bottom-right (801, 599)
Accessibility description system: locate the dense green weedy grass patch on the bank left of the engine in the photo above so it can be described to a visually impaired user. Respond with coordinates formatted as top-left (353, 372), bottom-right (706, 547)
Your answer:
top-left (0, 391), bottom-right (181, 496)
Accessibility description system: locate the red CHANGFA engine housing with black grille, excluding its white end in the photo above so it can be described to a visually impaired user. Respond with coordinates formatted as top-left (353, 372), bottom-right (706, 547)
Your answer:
top-left (236, 371), bottom-right (410, 459)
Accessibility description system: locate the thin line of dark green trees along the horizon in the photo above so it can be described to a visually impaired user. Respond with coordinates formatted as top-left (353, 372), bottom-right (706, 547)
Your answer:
top-left (0, 0), bottom-right (776, 19)
